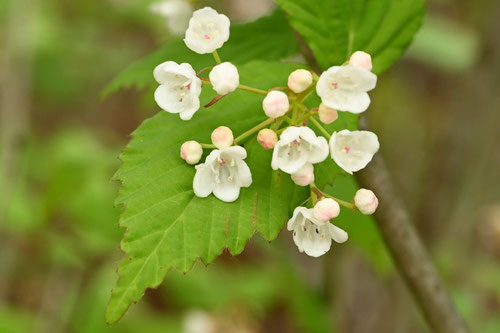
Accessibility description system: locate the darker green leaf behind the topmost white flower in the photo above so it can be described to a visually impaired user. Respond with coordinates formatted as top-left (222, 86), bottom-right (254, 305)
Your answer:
top-left (102, 11), bottom-right (298, 97)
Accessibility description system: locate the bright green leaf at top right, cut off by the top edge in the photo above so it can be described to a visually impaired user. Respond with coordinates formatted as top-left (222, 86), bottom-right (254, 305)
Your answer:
top-left (276, 0), bottom-right (424, 73)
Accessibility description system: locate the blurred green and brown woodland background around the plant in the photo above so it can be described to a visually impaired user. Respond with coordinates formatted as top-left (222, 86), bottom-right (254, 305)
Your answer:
top-left (0, 0), bottom-right (500, 333)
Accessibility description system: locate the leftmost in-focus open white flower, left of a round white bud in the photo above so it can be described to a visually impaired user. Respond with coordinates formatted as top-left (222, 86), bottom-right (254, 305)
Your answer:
top-left (153, 61), bottom-right (201, 120)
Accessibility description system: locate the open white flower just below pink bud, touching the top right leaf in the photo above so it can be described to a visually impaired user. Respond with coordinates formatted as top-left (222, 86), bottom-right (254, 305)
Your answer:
top-left (316, 65), bottom-right (377, 113)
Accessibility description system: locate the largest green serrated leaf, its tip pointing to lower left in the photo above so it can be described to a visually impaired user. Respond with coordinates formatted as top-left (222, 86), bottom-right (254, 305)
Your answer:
top-left (106, 62), bottom-right (307, 323)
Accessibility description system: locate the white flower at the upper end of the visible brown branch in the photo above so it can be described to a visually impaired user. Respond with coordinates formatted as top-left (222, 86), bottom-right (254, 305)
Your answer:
top-left (330, 130), bottom-right (380, 175)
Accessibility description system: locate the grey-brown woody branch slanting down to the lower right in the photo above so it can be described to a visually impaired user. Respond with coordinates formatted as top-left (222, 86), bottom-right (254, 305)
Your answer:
top-left (357, 122), bottom-right (469, 333)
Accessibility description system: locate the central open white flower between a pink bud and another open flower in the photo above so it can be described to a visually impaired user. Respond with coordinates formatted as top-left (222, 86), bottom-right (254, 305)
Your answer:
top-left (271, 126), bottom-right (328, 174)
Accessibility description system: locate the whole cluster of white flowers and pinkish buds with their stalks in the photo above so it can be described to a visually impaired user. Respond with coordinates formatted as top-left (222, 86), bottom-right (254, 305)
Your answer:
top-left (154, 7), bottom-right (379, 257)
